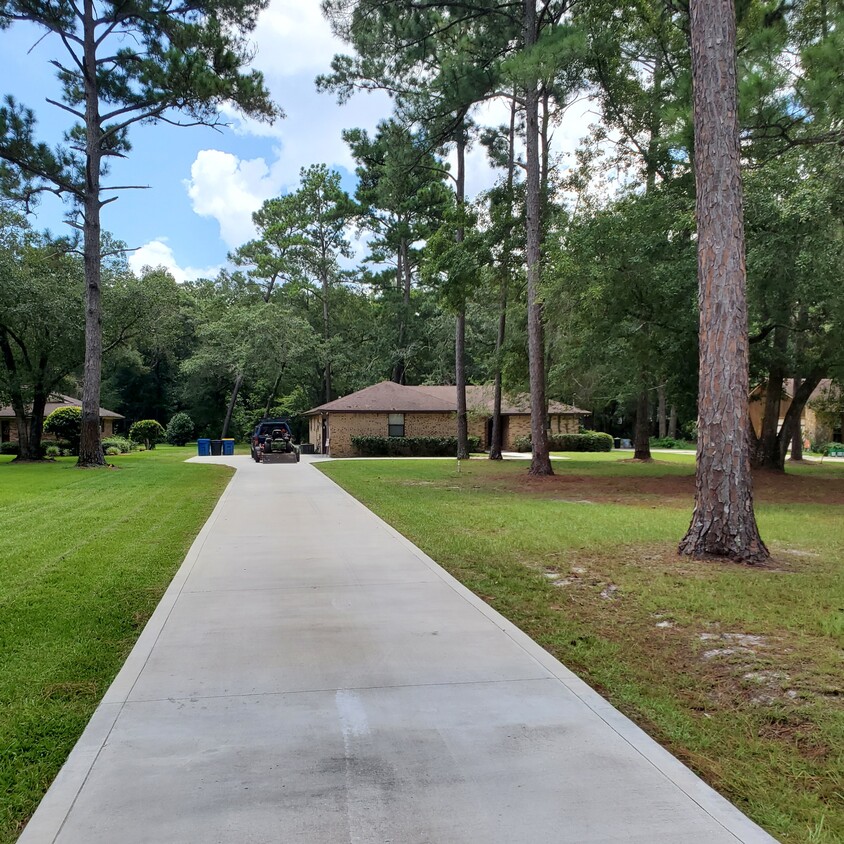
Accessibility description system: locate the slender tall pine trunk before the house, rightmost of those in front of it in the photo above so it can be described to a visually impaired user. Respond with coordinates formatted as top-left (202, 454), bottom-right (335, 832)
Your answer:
top-left (524, 0), bottom-right (554, 475)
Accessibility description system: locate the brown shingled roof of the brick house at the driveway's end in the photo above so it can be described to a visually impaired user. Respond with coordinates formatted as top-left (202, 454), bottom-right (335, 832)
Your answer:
top-left (305, 381), bottom-right (589, 416)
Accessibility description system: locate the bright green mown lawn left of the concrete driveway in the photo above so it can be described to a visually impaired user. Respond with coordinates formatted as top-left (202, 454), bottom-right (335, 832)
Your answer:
top-left (0, 446), bottom-right (232, 844)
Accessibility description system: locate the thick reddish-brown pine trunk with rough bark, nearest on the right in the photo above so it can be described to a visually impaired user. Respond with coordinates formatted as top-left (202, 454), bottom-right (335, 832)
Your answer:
top-left (679, 0), bottom-right (769, 563)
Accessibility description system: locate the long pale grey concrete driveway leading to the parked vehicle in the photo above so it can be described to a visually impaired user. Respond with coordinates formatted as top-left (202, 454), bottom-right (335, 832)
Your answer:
top-left (20, 457), bottom-right (773, 844)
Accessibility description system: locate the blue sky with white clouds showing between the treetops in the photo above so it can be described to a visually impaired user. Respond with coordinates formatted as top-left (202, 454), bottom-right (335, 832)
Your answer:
top-left (0, 0), bottom-right (586, 281)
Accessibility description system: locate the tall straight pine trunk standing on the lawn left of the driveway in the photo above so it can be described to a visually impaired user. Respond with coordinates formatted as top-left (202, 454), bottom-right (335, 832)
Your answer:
top-left (76, 0), bottom-right (106, 467)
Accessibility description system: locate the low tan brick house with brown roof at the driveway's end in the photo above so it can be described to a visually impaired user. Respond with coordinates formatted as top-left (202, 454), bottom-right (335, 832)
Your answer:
top-left (305, 381), bottom-right (589, 457)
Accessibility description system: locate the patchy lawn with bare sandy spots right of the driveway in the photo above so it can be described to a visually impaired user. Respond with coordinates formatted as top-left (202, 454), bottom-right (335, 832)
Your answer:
top-left (320, 454), bottom-right (844, 844)
